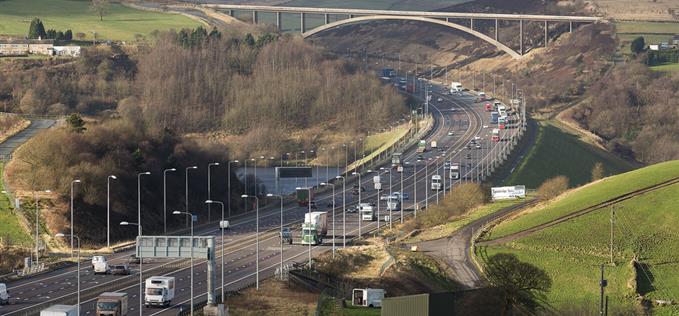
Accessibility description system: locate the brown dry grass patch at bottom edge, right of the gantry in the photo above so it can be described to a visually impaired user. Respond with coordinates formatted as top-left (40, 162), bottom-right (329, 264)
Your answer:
top-left (226, 279), bottom-right (318, 316)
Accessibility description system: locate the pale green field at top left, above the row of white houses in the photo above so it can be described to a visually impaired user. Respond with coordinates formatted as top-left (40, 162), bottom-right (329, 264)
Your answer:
top-left (0, 0), bottom-right (199, 40)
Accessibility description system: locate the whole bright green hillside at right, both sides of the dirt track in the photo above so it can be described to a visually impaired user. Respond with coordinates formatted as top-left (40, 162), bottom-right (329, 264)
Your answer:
top-left (482, 161), bottom-right (679, 315)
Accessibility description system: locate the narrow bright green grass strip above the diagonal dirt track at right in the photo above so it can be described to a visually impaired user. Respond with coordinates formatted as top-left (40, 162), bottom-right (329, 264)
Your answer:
top-left (488, 160), bottom-right (679, 239)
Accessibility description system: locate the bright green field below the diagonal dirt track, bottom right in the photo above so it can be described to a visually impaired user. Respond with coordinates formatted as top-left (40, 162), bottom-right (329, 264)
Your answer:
top-left (480, 179), bottom-right (679, 315)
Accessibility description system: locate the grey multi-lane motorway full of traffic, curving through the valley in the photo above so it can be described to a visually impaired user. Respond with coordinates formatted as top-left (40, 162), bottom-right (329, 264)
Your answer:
top-left (0, 82), bottom-right (518, 315)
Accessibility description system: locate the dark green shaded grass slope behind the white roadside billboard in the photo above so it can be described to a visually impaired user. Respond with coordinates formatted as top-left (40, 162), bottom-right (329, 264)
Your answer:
top-left (505, 122), bottom-right (632, 188)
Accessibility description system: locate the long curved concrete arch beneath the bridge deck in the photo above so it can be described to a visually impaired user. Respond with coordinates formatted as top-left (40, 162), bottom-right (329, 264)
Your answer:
top-left (302, 15), bottom-right (521, 59)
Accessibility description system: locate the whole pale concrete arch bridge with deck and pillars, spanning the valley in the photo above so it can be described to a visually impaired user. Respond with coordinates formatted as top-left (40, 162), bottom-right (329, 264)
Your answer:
top-left (201, 4), bottom-right (601, 58)
